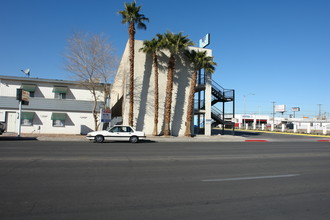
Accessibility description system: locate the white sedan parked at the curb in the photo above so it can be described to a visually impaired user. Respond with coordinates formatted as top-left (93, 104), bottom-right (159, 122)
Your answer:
top-left (86, 125), bottom-right (146, 143)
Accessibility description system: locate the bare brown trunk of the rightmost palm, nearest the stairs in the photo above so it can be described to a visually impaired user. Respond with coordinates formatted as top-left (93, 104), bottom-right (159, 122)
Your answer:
top-left (184, 70), bottom-right (197, 137)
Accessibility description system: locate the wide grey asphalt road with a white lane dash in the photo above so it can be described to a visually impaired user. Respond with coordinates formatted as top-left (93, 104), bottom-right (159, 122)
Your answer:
top-left (0, 141), bottom-right (330, 220)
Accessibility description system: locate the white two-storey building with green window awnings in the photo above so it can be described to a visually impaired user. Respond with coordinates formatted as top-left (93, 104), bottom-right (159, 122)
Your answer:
top-left (0, 75), bottom-right (108, 134)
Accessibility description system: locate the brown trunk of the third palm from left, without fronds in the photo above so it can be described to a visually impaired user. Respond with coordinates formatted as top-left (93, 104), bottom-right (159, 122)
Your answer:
top-left (164, 55), bottom-right (175, 136)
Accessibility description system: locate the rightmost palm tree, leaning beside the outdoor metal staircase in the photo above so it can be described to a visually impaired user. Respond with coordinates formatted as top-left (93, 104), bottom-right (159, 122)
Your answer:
top-left (184, 50), bottom-right (217, 137)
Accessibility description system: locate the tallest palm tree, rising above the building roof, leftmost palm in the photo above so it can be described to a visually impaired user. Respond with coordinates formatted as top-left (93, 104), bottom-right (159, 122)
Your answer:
top-left (118, 1), bottom-right (149, 126)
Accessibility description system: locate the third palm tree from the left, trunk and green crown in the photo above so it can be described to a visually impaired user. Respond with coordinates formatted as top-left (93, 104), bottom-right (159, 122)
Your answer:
top-left (162, 32), bottom-right (194, 136)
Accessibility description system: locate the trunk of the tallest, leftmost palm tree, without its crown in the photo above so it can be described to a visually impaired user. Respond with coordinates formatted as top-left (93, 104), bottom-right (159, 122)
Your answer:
top-left (128, 22), bottom-right (135, 126)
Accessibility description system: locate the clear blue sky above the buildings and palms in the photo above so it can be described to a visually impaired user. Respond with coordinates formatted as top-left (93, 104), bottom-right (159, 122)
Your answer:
top-left (0, 0), bottom-right (330, 116)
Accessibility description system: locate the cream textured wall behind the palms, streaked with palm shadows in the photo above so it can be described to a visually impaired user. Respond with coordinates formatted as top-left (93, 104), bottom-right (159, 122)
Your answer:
top-left (111, 40), bottom-right (212, 136)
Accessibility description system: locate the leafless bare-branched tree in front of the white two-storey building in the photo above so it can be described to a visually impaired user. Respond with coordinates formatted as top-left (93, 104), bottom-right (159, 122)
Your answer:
top-left (65, 33), bottom-right (118, 130)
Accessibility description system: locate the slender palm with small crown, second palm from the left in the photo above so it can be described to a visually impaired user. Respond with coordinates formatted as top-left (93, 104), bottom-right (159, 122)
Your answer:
top-left (140, 36), bottom-right (162, 136)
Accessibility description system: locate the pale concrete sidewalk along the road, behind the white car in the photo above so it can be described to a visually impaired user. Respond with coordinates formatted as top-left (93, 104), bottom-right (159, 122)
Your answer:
top-left (0, 133), bottom-right (246, 142)
